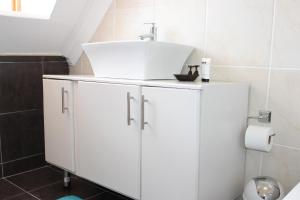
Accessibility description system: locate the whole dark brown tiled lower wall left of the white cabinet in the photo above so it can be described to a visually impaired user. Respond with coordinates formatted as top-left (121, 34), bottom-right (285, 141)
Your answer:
top-left (0, 56), bottom-right (69, 178)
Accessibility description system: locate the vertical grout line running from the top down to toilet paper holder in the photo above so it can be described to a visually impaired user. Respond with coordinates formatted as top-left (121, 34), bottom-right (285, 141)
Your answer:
top-left (265, 0), bottom-right (278, 110)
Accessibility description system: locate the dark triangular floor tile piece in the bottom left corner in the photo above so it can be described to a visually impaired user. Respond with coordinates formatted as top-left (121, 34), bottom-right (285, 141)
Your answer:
top-left (0, 179), bottom-right (24, 200)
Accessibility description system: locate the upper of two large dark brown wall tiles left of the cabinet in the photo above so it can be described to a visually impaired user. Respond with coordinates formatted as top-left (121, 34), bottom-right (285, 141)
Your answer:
top-left (0, 63), bottom-right (43, 113)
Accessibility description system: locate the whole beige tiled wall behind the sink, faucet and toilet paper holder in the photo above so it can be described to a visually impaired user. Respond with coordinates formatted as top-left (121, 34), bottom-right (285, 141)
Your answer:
top-left (71, 0), bottom-right (300, 194)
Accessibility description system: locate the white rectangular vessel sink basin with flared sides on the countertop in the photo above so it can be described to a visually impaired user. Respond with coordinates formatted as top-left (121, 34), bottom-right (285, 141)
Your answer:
top-left (82, 41), bottom-right (193, 80)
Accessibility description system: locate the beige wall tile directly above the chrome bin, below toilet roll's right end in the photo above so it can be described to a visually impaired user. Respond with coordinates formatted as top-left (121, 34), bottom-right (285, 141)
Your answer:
top-left (262, 146), bottom-right (300, 192)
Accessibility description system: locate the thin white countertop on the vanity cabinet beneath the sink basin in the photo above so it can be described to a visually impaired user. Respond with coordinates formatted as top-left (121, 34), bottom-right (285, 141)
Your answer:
top-left (43, 75), bottom-right (248, 90)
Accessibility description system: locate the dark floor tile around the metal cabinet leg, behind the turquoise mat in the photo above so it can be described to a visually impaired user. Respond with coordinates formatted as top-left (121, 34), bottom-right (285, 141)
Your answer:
top-left (30, 178), bottom-right (104, 200)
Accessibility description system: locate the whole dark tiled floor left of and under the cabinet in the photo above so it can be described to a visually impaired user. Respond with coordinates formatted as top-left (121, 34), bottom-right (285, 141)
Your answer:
top-left (0, 166), bottom-right (130, 200)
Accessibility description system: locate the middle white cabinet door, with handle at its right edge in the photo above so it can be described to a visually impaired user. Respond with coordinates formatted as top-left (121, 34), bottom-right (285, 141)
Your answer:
top-left (76, 82), bottom-right (140, 199)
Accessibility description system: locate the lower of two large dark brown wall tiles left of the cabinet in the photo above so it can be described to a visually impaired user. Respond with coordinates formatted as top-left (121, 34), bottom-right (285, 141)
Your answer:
top-left (0, 110), bottom-right (44, 162)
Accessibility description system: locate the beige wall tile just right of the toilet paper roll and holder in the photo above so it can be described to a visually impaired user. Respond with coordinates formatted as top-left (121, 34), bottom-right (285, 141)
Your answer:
top-left (269, 70), bottom-right (300, 148)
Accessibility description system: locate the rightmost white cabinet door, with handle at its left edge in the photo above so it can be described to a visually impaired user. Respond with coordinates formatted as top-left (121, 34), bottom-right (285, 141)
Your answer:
top-left (141, 87), bottom-right (200, 200)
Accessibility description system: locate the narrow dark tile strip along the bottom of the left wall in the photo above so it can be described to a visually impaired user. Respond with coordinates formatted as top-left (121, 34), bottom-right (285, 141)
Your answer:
top-left (3, 155), bottom-right (45, 177)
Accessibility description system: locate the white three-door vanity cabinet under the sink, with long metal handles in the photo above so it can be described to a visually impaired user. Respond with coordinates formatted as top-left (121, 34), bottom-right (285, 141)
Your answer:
top-left (44, 76), bottom-right (248, 200)
